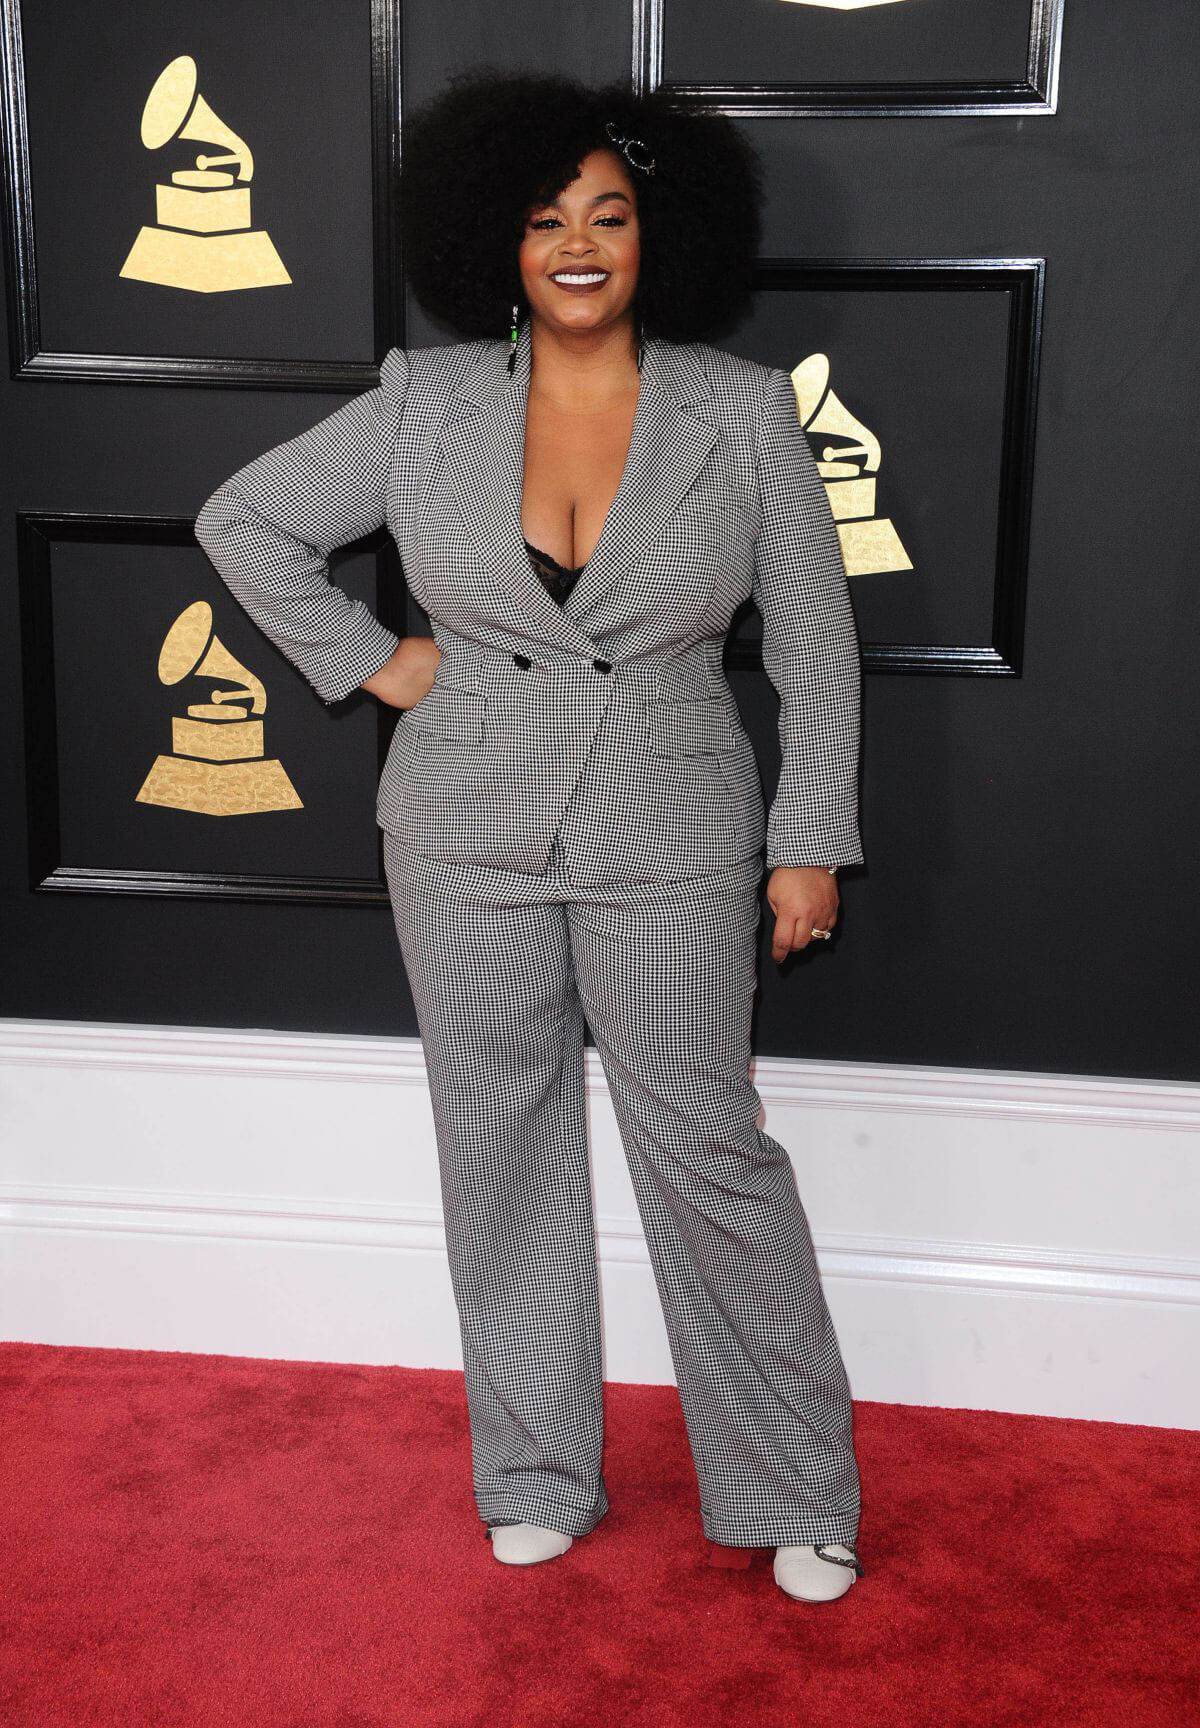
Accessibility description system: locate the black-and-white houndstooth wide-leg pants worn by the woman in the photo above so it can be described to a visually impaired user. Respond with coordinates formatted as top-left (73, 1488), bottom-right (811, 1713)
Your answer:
top-left (384, 831), bottom-right (859, 1547)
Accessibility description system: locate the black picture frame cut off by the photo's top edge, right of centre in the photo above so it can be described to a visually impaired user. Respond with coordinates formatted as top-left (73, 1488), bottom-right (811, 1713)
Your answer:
top-left (633, 0), bottom-right (1063, 119)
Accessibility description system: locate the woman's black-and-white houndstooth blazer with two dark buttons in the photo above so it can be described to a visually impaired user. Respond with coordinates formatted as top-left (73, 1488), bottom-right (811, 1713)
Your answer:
top-left (195, 323), bottom-right (863, 881)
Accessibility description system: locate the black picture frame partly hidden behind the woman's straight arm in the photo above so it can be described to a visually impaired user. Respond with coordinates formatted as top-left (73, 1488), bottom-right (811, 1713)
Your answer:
top-left (726, 257), bottom-right (1046, 677)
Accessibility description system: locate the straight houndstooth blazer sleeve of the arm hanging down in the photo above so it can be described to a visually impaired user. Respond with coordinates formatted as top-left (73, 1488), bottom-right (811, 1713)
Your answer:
top-left (754, 366), bottom-right (863, 869)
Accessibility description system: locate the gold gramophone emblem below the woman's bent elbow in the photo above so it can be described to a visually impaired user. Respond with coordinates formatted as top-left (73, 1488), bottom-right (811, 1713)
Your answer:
top-left (137, 600), bottom-right (304, 816)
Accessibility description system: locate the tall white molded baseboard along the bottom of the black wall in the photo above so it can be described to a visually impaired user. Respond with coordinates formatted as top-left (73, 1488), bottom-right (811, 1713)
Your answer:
top-left (0, 1020), bottom-right (1200, 1429)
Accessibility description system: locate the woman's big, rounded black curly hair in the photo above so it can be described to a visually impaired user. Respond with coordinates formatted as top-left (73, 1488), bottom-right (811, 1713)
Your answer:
top-left (399, 66), bottom-right (763, 342)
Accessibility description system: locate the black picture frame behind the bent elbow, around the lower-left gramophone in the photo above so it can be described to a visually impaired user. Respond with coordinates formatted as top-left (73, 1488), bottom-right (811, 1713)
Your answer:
top-left (16, 510), bottom-right (415, 907)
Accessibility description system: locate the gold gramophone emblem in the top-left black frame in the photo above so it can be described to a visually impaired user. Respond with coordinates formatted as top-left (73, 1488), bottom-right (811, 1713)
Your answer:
top-left (121, 54), bottom-right (292, 294)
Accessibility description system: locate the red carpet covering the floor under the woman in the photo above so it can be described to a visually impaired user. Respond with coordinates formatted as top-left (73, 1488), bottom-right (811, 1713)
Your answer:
top-left (0, 1344), bottom-right (1200, 1728)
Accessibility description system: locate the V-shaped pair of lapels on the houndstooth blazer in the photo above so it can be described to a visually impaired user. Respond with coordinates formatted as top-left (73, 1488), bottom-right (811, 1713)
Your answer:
top-left (441, 320), bottom-right (719, 651)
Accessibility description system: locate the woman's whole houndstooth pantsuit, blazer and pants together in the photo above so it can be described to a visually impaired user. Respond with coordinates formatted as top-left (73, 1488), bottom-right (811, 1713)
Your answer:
top-left (195, 327), bottom-right (874, 1547)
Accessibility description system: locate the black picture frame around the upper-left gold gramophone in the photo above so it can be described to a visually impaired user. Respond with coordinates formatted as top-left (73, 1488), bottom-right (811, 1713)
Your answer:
top-left (0, 0), bottom-right (406, 394)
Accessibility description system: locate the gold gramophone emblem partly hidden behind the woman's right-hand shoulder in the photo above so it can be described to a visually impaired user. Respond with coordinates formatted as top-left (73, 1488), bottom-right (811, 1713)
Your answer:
top-left (792, 354), bottom-right (913, 575)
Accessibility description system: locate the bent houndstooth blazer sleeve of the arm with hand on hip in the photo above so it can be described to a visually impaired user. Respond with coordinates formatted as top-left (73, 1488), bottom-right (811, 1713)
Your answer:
top-left (195, 347), bottom-right (408, 703)
